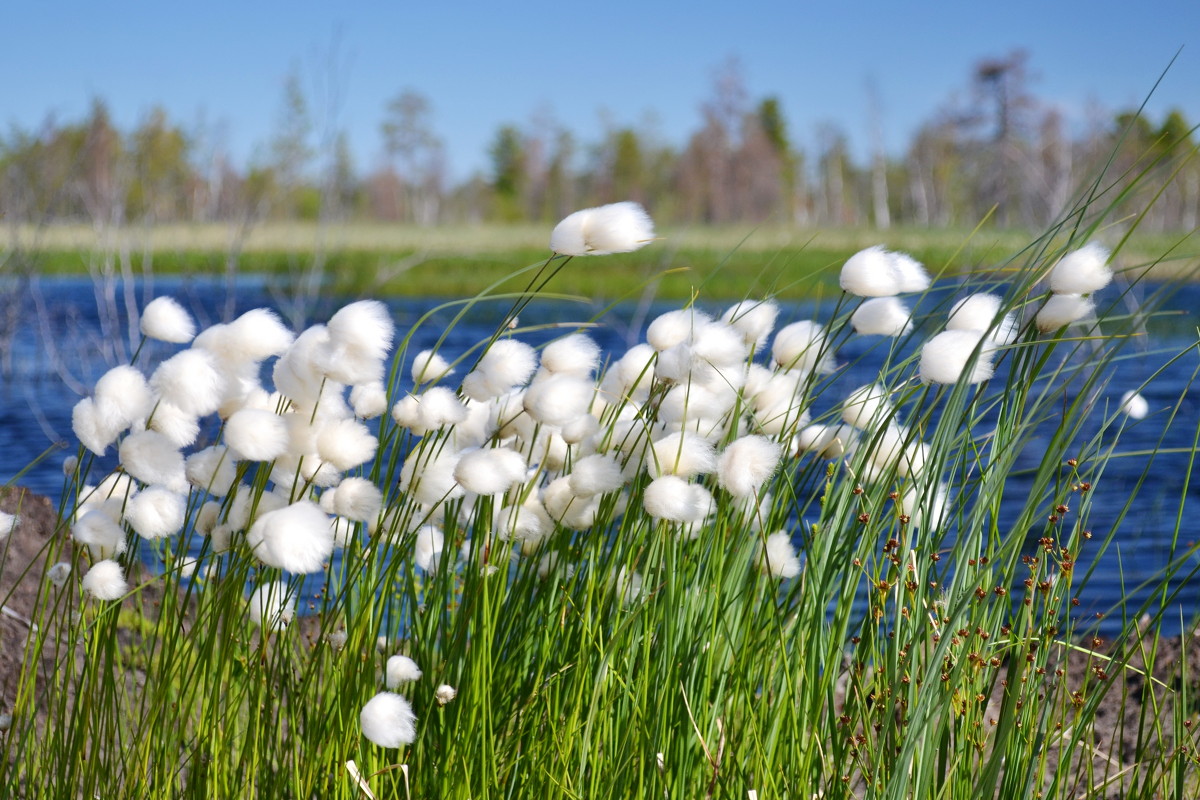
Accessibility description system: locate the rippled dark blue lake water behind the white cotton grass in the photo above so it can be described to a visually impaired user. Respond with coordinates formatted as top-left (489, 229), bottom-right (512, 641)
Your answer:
top-left (0, 276), bottom-right (1200, 630)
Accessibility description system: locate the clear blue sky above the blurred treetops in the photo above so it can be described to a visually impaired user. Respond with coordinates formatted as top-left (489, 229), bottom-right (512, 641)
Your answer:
top-left (0, 0), bottom-right (1200, 178)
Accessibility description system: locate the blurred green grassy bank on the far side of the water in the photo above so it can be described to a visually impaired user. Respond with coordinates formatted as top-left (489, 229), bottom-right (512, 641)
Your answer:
top-left (4, 223), bottom-right (1195, 299)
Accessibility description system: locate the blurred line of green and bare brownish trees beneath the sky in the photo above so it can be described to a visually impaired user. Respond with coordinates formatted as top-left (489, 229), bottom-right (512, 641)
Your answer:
top-left (0, 52), bottom-right (1200, 230)
